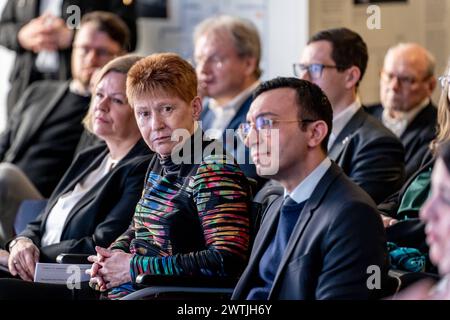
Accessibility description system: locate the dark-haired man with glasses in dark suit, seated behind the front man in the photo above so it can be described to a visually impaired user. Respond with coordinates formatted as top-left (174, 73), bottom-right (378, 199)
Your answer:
top-left (294, 28), bottom-right (404, 203)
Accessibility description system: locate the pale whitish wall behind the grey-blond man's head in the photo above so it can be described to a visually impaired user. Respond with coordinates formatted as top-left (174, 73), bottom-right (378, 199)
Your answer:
top-left (137, 0), bottom-right (309, 79)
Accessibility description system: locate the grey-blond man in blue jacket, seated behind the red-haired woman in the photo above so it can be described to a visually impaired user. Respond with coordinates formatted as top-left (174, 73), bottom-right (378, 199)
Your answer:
top-left (194, 16), bottom-right (264, 190)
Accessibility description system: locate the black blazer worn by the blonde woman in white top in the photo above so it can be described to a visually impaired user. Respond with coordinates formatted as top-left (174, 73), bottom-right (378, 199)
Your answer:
top-left (13, 139), bottom-right (153, 262)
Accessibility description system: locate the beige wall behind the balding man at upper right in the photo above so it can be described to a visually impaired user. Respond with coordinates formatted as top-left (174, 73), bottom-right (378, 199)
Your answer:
top-left (309, 0), bottom-right (450, 103)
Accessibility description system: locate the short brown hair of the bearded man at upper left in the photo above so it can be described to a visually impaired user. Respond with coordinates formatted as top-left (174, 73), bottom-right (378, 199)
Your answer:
top-left (80, 11), bottom-right (130, 51)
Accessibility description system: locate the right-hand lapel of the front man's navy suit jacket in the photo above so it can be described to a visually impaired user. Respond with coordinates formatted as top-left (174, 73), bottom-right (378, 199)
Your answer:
top-left (269, 163), bottom-right (342, 299)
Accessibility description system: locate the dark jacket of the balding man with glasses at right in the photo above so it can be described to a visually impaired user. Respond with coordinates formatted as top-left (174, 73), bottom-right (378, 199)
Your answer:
top-left (366, 102), bottom-right (437, 179)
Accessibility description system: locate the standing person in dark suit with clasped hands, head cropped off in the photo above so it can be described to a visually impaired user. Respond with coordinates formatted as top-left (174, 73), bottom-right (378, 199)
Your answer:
top-left (0, 0), bottom-right (136, 116)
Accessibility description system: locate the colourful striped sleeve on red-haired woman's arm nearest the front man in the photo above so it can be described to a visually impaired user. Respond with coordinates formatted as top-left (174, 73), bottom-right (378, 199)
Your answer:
top-left (130, 156), bottom-right (250, 280)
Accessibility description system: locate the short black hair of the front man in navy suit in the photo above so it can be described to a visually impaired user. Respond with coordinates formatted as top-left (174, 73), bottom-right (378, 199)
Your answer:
top-left (253, 77), bottom-right (333, 153)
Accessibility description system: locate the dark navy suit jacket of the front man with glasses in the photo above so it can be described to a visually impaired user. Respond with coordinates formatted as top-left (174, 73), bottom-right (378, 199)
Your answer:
top-left (232, 163), bottom-right (387, 300)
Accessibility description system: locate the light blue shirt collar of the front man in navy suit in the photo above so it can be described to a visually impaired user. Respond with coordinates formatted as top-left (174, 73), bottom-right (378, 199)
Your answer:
top-left (284, 157), bottom-right (331, 203)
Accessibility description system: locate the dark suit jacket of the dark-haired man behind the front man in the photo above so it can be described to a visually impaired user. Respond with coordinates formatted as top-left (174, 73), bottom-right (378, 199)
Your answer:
top-left (328, 109), bottom-right (405, 203)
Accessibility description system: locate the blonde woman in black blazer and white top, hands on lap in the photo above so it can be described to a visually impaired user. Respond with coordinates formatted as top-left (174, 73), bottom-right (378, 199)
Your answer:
top-left (0, 55), bottom-right (152, 280)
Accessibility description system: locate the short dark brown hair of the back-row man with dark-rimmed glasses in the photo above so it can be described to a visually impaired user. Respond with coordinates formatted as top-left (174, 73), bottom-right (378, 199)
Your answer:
top-left (308, 28), bottom-right (369, 87)
